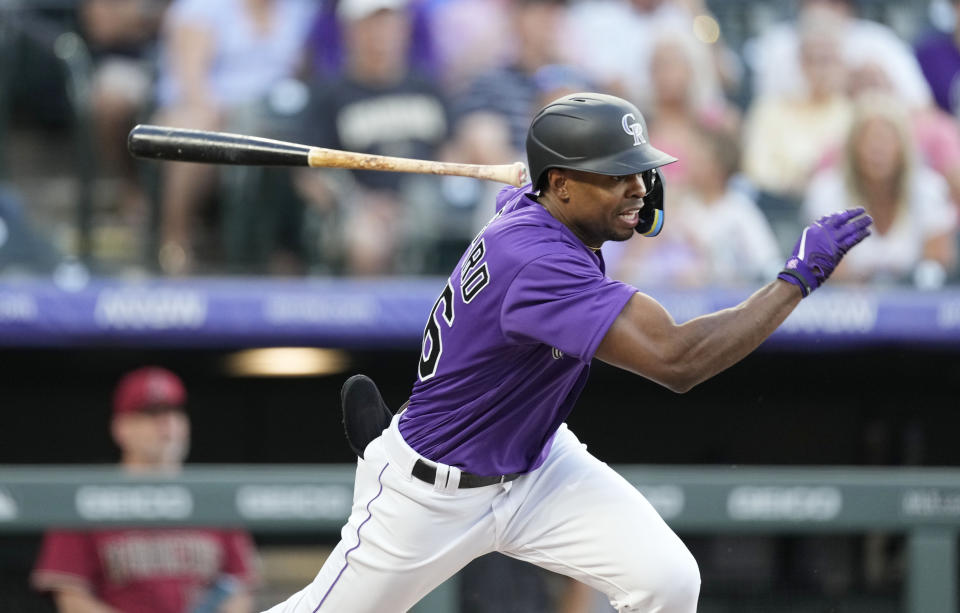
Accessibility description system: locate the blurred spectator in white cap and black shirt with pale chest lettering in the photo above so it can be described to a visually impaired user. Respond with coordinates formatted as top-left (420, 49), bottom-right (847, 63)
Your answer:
top-left (296, 0), bottom-right (449, 275)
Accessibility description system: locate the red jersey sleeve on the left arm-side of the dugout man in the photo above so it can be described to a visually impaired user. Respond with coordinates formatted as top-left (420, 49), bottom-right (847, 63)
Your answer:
top-left (30, 531), bottom-right (100, 593)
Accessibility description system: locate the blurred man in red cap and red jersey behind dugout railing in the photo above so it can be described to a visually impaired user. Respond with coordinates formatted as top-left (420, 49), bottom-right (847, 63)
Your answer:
top-left (31, 367), bottom-right (257, 613)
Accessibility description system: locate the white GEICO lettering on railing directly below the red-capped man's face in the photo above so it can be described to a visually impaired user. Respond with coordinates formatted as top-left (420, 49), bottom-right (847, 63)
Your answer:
top-left (76, 485), bottom-right (193, 520)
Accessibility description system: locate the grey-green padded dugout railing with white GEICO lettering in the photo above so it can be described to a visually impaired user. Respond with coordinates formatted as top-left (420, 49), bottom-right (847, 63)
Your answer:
top-left (0, 465), bottom-right (960, 613)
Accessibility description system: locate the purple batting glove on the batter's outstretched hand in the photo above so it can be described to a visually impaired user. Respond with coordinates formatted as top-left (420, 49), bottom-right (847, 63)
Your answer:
top-left (777, 207), bottom-right (873, 298)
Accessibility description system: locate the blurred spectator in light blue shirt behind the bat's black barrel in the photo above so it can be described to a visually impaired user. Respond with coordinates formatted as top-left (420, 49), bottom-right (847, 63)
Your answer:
top-left (157, 0), bottom-right (316, 275)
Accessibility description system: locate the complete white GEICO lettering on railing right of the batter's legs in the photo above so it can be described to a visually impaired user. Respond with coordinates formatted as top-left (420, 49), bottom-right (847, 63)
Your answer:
top-left (727, 485), bottom-right (843, 521)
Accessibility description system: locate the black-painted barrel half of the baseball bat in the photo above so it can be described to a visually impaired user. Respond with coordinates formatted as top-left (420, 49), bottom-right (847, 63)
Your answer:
top-left (127, 124), bottom-right (310, 166)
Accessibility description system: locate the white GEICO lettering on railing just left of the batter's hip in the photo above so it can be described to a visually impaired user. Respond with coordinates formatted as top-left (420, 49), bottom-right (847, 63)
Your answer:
top-left (236, 485), bottom-right (352, 520)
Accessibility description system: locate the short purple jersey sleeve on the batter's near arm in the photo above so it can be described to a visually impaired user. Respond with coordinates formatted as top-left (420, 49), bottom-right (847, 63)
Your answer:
top-left (500, 252), bottom-right (637, 362)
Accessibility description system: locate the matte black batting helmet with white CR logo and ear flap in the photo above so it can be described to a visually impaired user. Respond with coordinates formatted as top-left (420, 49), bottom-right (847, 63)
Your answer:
top-left (527, 93), bottom-right (677, 236)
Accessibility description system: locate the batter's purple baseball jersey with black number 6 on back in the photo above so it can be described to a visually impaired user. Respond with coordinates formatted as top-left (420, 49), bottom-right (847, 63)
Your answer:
top-left (399, 185), bottom-right (637, 475)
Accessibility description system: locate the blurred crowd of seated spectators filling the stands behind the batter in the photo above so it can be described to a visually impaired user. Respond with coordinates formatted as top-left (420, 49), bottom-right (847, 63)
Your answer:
top-left (0, 0), bottom-right (960, 288)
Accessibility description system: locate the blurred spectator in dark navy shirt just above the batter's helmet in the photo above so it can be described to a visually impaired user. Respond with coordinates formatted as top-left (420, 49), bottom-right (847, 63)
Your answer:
top-left (454, 0), bottom-right (567, 151)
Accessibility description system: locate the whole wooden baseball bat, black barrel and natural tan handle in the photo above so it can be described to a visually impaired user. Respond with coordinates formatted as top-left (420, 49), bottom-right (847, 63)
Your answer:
top-left (127, 124), bottom-right (529, 187)
